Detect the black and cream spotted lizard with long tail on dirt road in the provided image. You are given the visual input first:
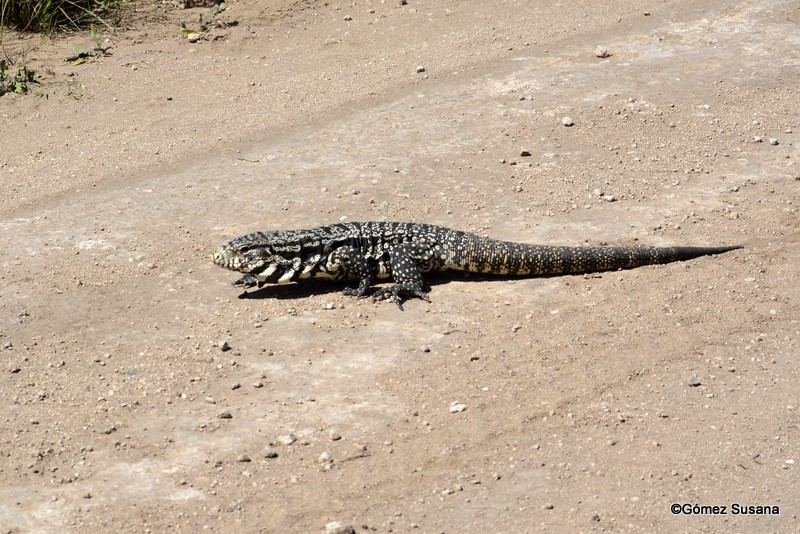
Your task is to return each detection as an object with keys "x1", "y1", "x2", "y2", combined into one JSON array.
[{"x1": 212, "y1": 222, "x2": 742, "y2": 310}]
